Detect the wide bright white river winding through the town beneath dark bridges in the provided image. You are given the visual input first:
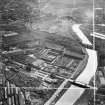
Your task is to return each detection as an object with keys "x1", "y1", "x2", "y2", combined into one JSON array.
[{"x1": 56, "y1": 24, "x2": 98, "y2": 105}]
